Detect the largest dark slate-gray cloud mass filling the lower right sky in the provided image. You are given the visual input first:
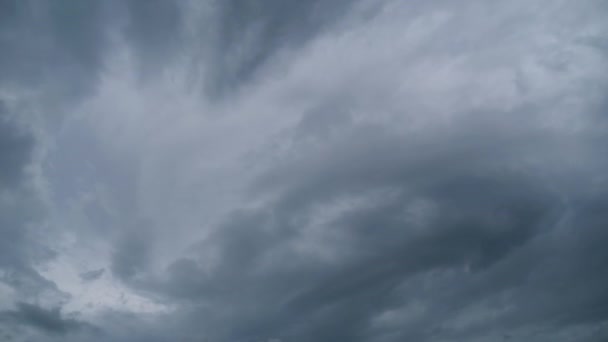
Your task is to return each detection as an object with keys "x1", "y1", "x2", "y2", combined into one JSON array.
[{"x1": 102, "y1": 110, "x2": 606, "y2": 341}]
